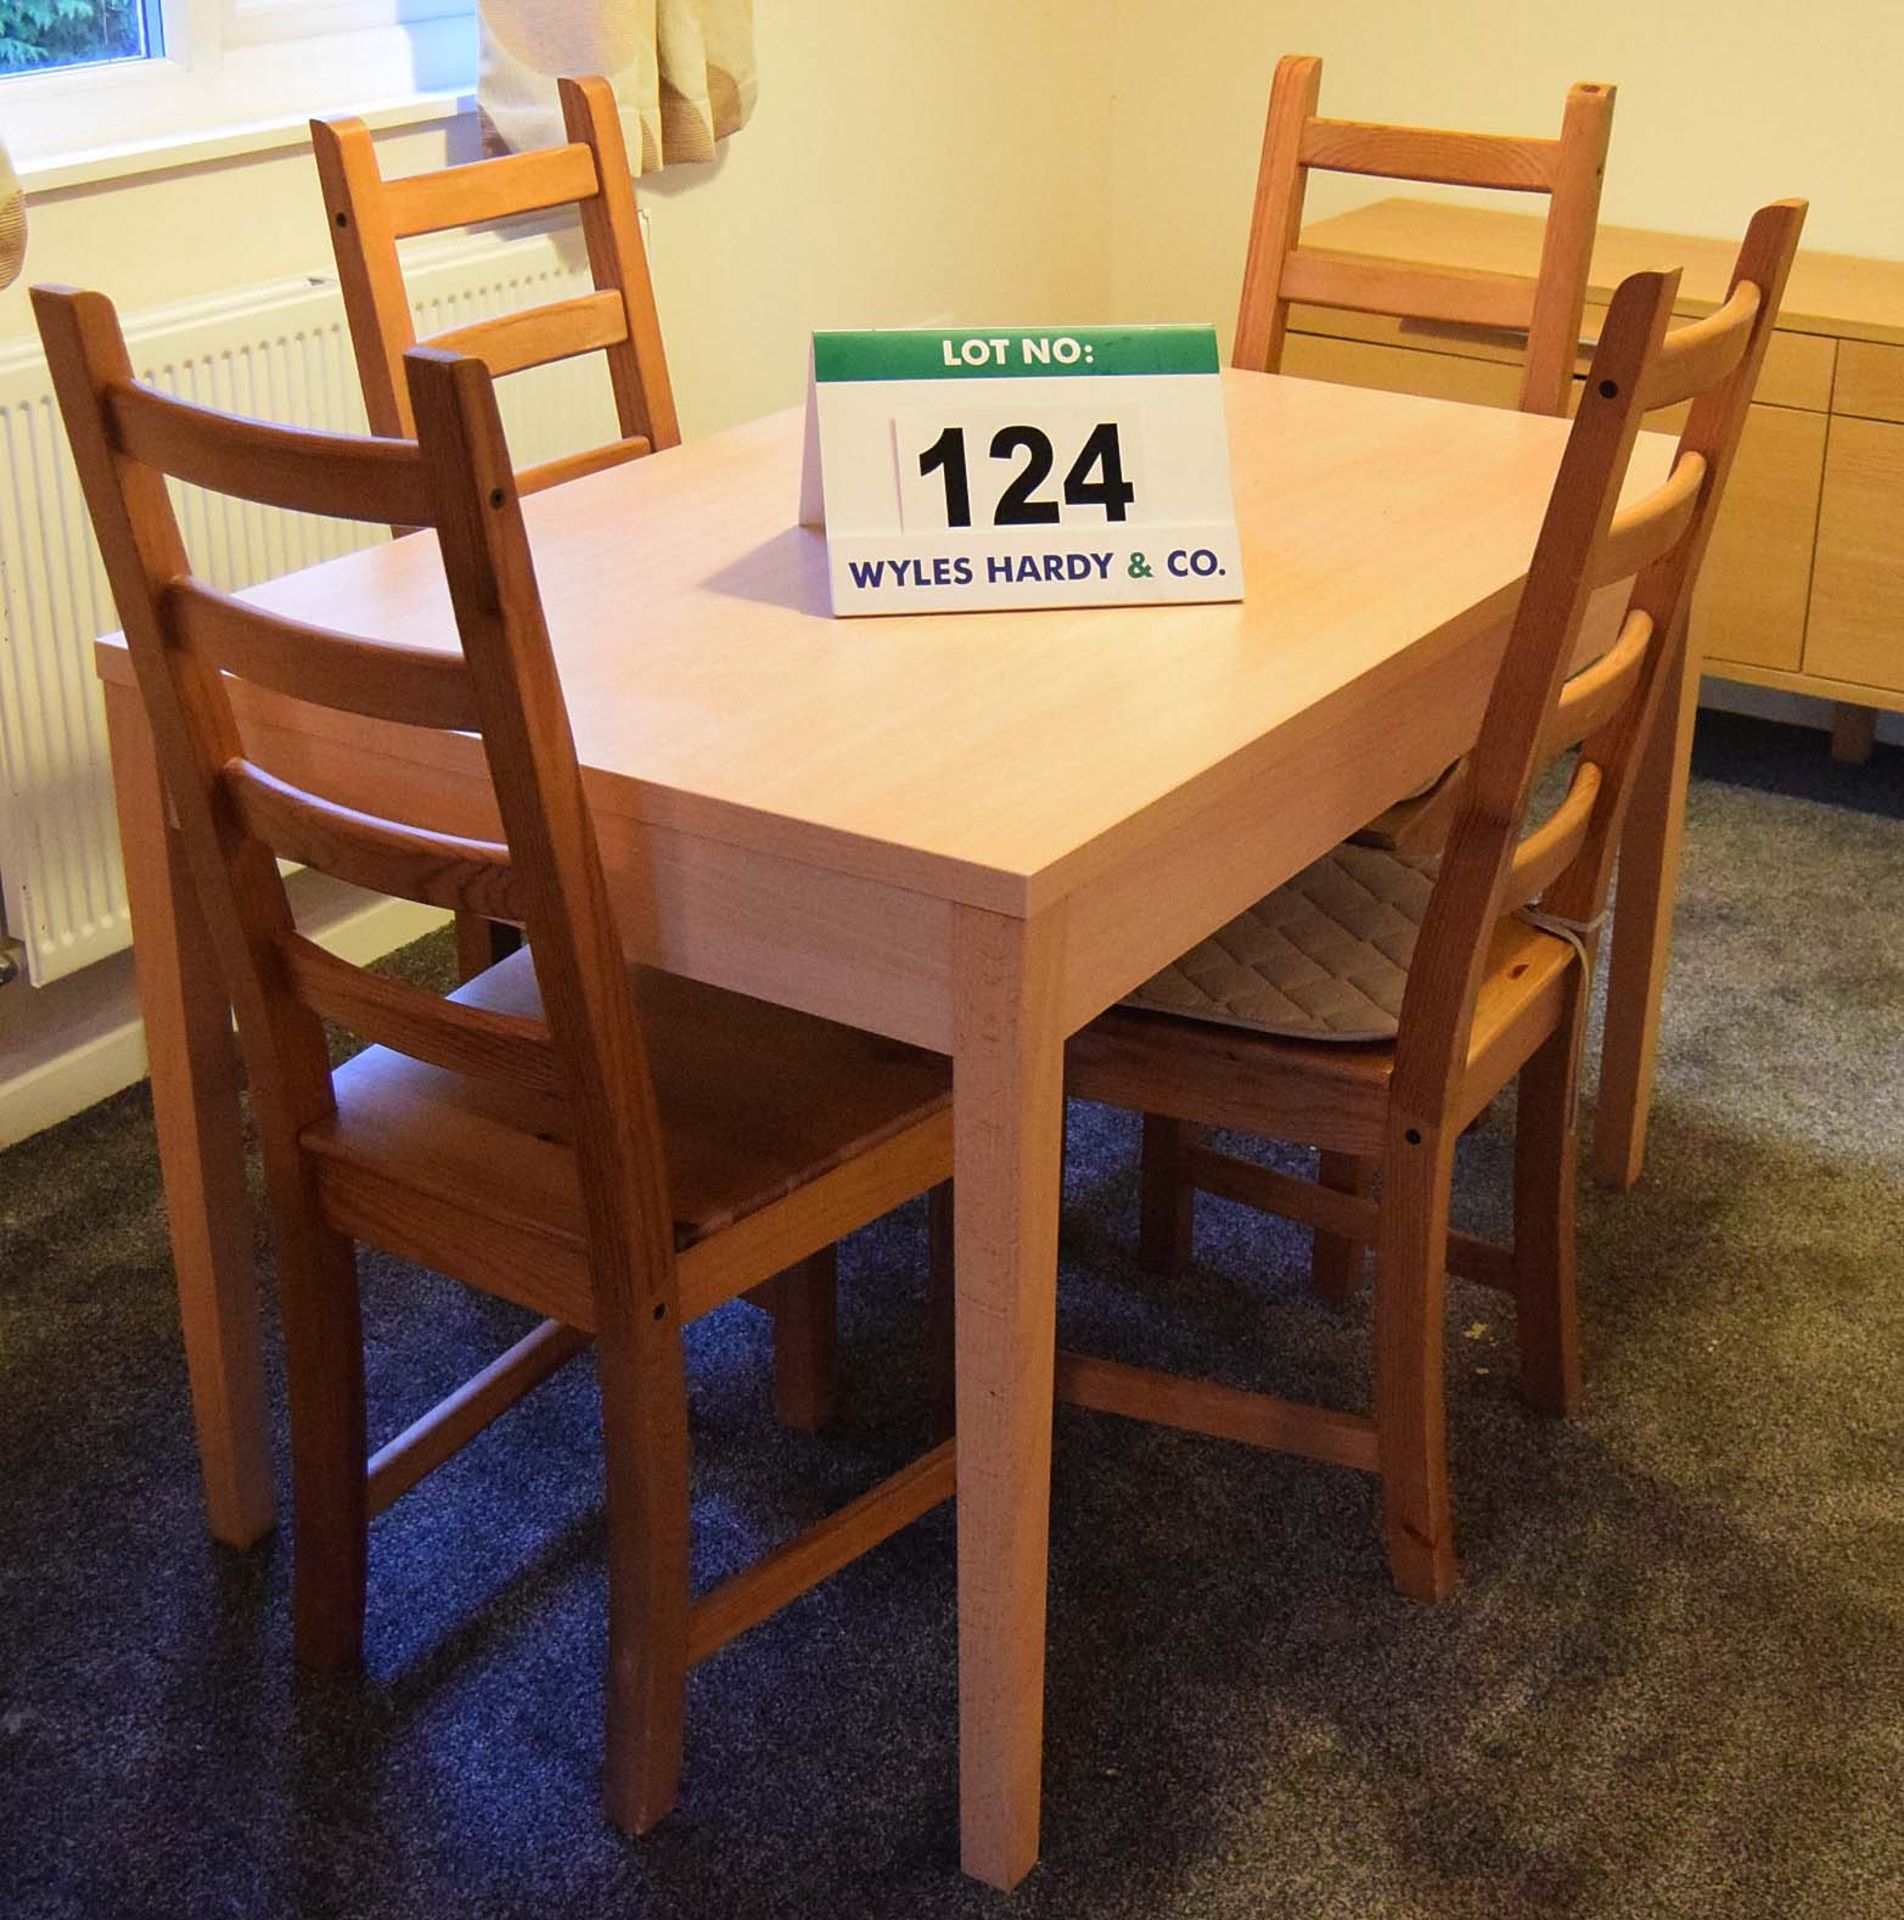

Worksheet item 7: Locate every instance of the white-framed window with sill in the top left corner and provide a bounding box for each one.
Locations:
[0,0,476,170]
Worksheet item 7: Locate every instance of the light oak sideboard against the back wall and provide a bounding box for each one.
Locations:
[1282,198,1904,758]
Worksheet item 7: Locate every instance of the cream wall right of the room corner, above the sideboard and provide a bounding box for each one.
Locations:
[1109,0,1904,338]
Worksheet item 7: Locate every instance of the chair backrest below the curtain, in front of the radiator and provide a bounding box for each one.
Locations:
[311,79,681,490]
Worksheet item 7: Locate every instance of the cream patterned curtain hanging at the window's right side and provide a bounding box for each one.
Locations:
[476,0,754,173]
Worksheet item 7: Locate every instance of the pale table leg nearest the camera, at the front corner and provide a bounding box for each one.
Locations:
[952,908,1063,1887]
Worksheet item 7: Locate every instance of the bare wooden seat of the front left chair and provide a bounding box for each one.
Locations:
[305,948,952,1327]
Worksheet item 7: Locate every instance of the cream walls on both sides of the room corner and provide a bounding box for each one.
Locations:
[11,0,1904,416]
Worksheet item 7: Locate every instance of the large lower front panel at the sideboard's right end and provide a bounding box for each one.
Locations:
[1804,416,1904,693]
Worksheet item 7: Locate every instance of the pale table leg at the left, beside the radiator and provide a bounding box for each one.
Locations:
[106,685,274,1548]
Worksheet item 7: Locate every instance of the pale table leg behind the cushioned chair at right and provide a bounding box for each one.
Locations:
[1593,618,1699,1188]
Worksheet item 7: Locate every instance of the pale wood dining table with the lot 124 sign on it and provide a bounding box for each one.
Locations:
[98,372,1673,1887]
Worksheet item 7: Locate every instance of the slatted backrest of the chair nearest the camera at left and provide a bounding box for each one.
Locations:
[33,286,674,1327]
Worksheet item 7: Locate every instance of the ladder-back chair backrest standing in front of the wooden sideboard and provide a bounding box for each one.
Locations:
[1232,54,1614,413]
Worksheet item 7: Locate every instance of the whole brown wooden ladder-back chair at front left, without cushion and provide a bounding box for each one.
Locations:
[35,288,967,1830]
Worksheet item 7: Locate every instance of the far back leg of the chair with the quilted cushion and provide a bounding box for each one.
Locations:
[1514,985,1585,1415]
